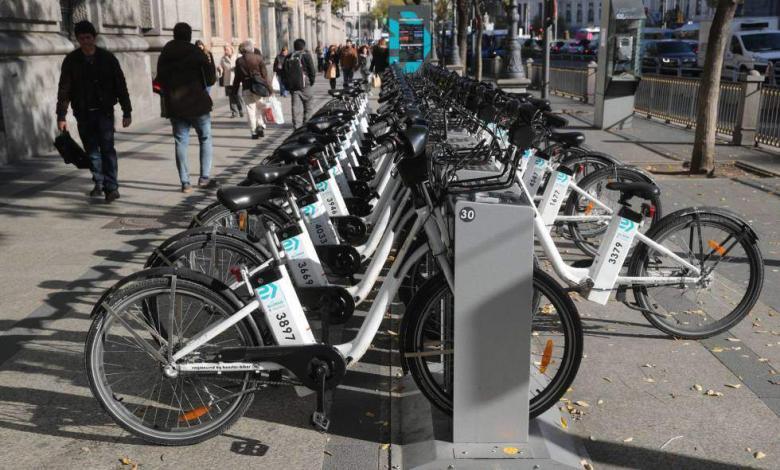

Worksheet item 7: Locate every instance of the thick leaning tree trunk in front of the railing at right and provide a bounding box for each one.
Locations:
[690,0,740,175]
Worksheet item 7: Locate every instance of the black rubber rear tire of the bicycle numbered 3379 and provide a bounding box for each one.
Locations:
[628,209,764,339]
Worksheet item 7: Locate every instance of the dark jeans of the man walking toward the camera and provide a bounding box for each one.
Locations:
[77,111,119,191]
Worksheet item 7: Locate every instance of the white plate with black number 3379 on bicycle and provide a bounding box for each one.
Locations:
[588,214,641,305]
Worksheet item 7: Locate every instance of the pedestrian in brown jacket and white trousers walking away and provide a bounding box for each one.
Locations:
[233,40,271,139]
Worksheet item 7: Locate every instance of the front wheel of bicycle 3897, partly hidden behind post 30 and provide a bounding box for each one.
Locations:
[401,269,583,418]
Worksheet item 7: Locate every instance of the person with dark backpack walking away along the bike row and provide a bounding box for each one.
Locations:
[282,38,317,129]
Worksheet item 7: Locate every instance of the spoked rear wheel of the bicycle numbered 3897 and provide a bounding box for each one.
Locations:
[85,271,259,445]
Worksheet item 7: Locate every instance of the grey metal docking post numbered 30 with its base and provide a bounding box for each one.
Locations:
[392,170,582,469]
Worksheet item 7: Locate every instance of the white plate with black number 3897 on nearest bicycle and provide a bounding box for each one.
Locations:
[257,266,315,346]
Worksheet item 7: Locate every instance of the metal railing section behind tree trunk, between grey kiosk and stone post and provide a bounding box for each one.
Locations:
[634,75,744,135]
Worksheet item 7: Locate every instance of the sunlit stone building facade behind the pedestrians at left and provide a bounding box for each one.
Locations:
[0,0,344,165]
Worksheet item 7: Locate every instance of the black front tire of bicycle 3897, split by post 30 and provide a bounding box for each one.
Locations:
[401,269,584,418]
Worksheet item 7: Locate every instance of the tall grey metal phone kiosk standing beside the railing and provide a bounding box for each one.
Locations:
[593,0,645,129]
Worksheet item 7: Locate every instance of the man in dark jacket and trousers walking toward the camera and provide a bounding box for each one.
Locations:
[57,21,133,203]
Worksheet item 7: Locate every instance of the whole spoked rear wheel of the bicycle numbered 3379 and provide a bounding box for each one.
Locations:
[628,211,764,339]
